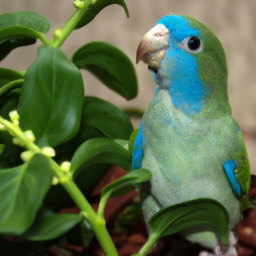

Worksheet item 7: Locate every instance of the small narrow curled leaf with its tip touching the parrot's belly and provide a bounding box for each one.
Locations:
[101,169,152,198]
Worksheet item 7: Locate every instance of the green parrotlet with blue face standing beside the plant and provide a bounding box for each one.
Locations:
[132,15,251,255]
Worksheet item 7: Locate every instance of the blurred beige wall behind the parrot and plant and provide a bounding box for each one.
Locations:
[0,0,256,174]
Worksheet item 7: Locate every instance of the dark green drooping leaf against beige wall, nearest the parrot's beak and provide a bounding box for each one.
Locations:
[72,42,138,100]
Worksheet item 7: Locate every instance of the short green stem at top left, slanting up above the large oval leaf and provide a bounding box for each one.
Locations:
[51,4,89,47]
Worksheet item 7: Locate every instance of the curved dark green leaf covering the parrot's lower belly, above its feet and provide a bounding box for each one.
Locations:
[148,199,229,244]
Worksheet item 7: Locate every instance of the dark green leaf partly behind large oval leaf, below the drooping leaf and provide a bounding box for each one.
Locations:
[82,97,133,140]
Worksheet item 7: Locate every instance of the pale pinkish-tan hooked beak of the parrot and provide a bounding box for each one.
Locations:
[136,24,169,69]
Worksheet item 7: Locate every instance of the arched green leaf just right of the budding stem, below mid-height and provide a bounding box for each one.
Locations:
[71,138,131,172]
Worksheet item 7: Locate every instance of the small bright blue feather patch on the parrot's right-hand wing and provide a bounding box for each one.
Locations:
[223,160,242,198]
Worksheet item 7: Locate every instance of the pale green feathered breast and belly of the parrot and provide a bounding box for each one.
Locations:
[141,89,240,227]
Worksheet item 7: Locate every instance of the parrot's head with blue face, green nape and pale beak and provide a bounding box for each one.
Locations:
[136,15,229,115]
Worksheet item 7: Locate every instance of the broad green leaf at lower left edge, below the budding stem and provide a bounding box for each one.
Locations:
[0,154,52,235]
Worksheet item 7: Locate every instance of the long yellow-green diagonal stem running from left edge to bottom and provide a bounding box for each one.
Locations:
[0,115,118,256]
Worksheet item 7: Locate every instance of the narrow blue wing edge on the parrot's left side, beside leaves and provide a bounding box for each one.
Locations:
[132,123,144,170]
